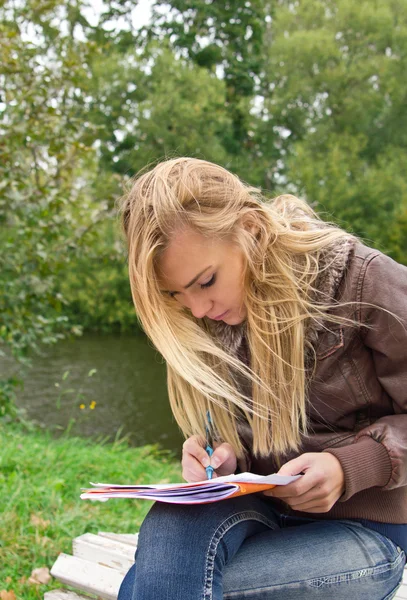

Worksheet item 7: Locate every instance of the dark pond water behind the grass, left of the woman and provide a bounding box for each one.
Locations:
[3,334,183,456]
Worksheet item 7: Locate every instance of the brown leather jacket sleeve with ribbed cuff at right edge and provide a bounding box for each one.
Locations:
[325,253,407,502]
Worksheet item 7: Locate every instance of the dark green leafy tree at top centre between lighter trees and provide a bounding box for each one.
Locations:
[148,0,270,158]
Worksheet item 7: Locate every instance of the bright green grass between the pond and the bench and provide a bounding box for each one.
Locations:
[0,423,181,600]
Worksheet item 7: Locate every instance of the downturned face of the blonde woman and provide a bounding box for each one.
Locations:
[158,229,247,325]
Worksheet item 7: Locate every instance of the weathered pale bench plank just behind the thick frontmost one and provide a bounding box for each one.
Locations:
[72,533,134,575]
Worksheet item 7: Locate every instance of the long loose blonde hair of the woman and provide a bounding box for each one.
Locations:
[121,158,356,456]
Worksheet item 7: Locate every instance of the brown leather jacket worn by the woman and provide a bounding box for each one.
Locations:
[242,243,407,523]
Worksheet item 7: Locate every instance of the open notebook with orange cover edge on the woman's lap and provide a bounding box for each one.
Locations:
[81,473,301,504]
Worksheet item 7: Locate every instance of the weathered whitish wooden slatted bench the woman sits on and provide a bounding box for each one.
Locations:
[44,531,407,600]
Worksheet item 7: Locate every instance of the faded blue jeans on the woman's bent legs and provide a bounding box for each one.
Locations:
[118,495,405,600]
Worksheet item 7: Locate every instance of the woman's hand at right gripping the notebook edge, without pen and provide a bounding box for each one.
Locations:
[264,452,345,513]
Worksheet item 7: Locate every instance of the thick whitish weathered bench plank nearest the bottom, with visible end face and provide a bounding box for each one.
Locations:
[51,554,123,600]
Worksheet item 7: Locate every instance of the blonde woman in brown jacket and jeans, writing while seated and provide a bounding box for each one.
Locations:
[119,158,407,600]
